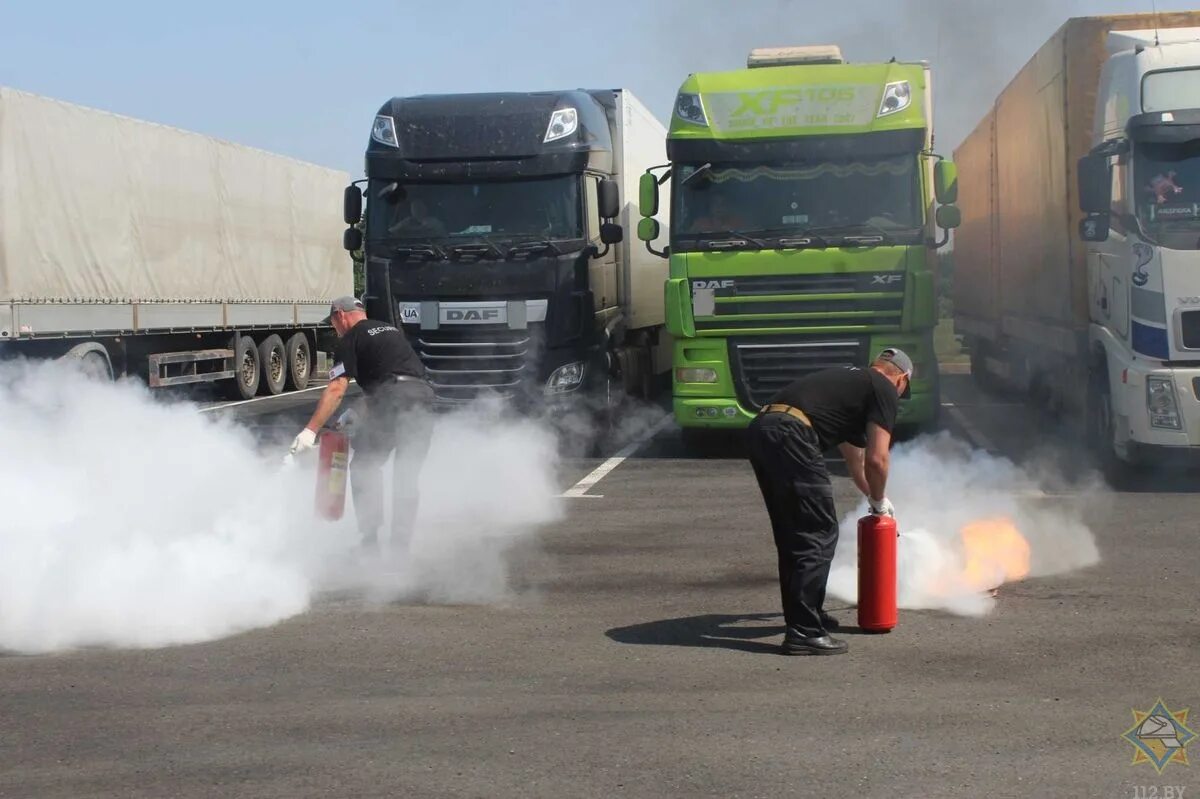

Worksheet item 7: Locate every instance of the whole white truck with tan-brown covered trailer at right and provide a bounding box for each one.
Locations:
[954,12,1200,475]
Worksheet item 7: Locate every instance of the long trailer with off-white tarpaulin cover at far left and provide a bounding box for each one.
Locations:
[0,88,354,398]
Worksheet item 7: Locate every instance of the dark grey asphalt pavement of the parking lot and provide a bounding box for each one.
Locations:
[0,376,1200,799]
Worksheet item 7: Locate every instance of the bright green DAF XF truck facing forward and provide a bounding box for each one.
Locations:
[638,46,960,440]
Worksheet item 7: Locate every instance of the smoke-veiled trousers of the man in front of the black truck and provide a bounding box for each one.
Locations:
[350,380,433,547]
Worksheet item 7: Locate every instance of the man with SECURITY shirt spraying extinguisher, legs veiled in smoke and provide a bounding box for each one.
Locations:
[292,296,433,548]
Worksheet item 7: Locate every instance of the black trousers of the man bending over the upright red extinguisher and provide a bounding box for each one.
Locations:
[749,414,838,636]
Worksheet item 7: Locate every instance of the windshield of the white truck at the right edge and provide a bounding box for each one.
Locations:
[1134,140,1200,250]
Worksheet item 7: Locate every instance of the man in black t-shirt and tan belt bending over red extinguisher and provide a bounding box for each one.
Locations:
[749,348,912,655]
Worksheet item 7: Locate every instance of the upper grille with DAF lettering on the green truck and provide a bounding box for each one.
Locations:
[696,272,906,330]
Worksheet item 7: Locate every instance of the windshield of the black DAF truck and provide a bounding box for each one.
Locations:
[367,175,583,244]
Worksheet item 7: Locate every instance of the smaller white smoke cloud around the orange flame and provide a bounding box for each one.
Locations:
[828,433,1100,615]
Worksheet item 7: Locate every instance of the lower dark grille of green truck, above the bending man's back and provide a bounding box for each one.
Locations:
[730,336,868,410]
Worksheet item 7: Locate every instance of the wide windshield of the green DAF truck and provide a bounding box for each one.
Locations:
[672,155,922,244]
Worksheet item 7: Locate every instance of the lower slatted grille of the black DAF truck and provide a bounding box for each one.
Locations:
[413,326,540,403]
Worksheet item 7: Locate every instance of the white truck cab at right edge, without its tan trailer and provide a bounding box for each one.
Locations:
[1079,28,1200,463]
